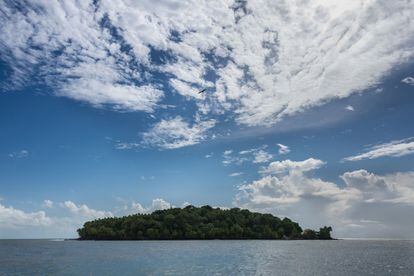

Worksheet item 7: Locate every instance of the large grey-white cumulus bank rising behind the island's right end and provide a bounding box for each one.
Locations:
[235,158,414,238]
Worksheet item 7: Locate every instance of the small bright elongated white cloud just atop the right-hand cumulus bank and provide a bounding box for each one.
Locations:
[260,158,325,174]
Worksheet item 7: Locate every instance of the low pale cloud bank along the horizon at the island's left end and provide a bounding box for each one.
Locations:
[0,198,174,238]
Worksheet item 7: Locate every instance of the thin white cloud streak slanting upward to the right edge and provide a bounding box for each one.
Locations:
[344,137,414,161]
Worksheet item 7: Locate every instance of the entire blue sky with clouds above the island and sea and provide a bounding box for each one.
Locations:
[0,0,414,239]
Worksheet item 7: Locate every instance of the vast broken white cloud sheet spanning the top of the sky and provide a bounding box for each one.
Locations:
[0,0,414,130]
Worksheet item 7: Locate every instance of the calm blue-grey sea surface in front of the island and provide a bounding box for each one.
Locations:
[0,240,414,275]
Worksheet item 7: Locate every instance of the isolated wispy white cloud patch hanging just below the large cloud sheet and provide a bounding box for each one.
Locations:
[142,116,216,149]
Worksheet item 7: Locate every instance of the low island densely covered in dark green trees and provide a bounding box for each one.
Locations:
[78,205,332,240]
